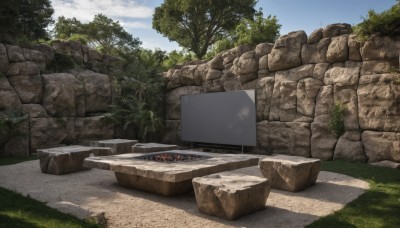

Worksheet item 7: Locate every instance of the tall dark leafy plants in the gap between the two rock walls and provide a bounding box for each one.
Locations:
[105,52,164,141]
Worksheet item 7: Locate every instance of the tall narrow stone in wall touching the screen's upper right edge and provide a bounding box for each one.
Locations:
[256,77,275,121]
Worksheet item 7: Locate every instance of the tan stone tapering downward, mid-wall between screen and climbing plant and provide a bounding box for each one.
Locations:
[296,78,322,117]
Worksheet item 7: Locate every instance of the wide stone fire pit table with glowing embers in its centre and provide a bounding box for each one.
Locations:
[83,150,259,196]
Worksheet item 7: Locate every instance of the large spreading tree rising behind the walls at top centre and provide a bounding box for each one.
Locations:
[153,0,257,59]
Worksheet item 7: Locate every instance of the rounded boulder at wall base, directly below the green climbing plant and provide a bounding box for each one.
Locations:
[333,131,366,162]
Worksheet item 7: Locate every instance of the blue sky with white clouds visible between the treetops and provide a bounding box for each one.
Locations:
[52,0,396,51]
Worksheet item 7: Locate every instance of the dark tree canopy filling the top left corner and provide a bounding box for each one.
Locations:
[0,0,54,42]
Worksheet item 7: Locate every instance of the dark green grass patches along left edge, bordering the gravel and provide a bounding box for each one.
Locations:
[0,156,99,228]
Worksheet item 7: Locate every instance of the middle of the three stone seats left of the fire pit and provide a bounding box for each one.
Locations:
[90,139,138,155]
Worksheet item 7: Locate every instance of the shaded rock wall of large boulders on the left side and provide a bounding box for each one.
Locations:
[0,41,122,155]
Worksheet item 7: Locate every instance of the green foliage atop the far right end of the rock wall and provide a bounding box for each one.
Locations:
[355,0,400,39]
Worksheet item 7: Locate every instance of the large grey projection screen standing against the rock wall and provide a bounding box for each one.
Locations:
[181,90,257,146]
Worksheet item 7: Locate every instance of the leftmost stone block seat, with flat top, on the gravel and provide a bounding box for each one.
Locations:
[37,145,110,175]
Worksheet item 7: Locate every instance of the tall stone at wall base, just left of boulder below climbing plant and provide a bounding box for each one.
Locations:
[311,115,337,160]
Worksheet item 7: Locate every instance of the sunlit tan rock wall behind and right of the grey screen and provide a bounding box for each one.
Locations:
[164,24,400,162]
